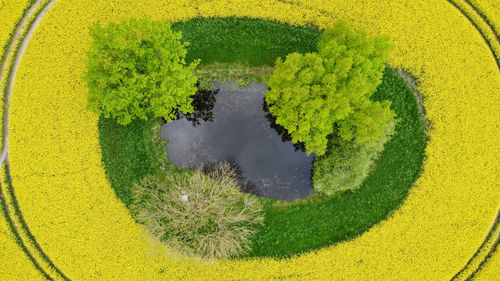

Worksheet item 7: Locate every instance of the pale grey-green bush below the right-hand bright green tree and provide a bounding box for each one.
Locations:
[313,119,396,195]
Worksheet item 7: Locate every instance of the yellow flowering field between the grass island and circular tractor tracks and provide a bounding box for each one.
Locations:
[4,0,500,280]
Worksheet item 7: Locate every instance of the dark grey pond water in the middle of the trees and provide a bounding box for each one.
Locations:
[161,83,313,200]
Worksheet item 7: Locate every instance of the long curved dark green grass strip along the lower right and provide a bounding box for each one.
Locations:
[251,69,425,257]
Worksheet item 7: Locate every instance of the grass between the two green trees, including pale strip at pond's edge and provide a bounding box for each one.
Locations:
[172,17,321,89]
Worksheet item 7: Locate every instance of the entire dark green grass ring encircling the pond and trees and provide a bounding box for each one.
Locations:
[95,18,425,257]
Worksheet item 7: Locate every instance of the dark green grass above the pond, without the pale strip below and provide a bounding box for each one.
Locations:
[172,18,321,66]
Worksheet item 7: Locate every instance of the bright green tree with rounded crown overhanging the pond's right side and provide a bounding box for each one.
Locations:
[266,20,394,155]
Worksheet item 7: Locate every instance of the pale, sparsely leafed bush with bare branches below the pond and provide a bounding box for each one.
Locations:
[132,163,263,258]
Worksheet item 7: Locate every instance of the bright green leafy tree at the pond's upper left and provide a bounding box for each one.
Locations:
[84,19,198,125]
